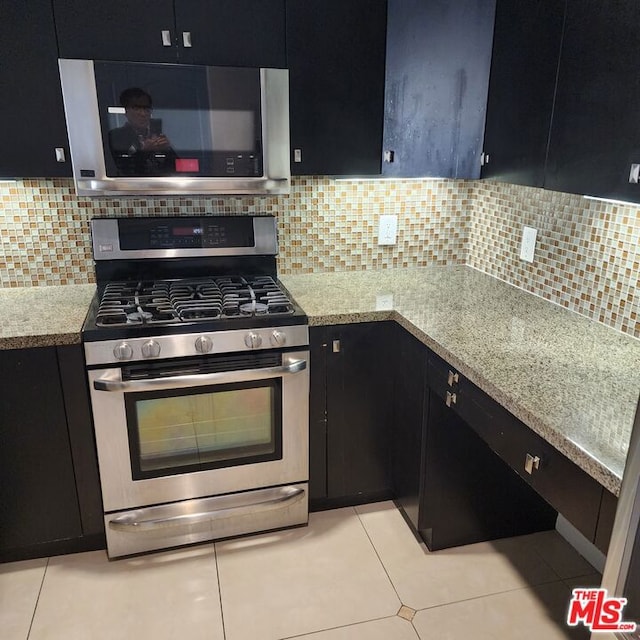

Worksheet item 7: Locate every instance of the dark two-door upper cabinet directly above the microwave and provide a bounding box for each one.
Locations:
[53,0,286,67]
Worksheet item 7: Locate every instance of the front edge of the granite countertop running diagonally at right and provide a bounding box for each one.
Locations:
[396,312,622,496]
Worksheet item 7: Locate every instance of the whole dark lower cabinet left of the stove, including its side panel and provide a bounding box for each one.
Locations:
[0,345,104,561]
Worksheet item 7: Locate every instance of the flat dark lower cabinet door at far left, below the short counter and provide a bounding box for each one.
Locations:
[0,347,82,552]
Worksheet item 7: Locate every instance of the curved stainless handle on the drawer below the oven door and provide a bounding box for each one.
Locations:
[109,486,305,533]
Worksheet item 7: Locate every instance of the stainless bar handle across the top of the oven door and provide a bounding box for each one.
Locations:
[93,360,307,392]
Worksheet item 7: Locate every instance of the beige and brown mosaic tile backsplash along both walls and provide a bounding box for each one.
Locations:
[0,177,640,337]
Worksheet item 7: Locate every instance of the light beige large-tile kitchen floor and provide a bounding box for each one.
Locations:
[0,502,600,640]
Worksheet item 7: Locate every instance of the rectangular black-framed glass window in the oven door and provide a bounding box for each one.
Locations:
[125,378,282,480]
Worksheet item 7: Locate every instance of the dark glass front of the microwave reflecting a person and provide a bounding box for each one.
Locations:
[94,62,262,178]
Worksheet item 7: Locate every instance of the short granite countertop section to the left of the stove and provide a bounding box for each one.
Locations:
[0,284,96,349]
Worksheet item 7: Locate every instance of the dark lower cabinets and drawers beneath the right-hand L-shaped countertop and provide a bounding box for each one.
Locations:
[310,322,616,551]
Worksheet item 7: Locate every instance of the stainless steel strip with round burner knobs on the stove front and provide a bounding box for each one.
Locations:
[84,325,309,365]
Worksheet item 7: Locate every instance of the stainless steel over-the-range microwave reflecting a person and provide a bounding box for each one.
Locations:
[58,59,290,196]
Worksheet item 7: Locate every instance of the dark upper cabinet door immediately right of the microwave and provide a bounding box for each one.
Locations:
[287,0,387,175]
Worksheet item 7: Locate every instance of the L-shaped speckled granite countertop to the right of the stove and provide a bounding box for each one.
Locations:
[280,267,640,495]
